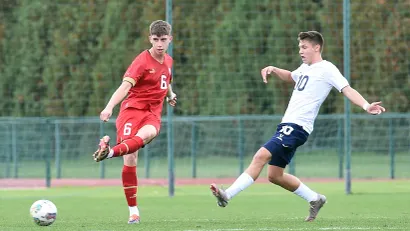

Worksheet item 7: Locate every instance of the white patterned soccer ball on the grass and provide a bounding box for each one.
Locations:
[30,200,57,226]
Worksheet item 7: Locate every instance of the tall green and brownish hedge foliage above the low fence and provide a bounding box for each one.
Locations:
[0,0,410,116]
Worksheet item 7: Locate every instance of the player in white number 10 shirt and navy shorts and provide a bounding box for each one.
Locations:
[210,31,385,221]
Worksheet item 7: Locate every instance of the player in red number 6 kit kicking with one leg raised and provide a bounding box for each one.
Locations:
[93,20,177,224]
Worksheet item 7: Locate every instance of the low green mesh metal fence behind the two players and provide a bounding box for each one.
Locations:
[0,114,410,185]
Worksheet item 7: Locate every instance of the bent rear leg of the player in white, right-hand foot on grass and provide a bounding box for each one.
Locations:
[268,165,326,221]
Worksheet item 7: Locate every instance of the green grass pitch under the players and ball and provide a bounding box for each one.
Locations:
[0,180,410,231]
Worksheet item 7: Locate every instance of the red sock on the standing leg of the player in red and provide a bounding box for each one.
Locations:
[122,165,138,206]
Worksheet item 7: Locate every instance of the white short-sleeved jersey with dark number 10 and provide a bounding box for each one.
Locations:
[282,60,349,134]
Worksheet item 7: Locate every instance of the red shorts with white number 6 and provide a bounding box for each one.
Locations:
[115,108,161,143]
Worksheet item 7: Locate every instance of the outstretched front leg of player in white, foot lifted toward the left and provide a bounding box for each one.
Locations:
[210,147,271,207]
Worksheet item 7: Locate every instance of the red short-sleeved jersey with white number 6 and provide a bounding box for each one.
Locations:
[121,50,173,115]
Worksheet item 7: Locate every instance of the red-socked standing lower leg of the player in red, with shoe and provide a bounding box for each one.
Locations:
[122,151,140,224]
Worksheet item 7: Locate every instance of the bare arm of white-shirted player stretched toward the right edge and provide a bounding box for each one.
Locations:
[342,86,386,115]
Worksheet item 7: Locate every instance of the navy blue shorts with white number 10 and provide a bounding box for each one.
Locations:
[263,123,309,168]
